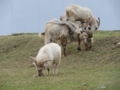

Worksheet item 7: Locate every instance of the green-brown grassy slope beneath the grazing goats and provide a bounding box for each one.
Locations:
[0,31,120,90]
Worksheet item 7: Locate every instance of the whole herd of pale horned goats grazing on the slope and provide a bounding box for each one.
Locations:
[30,4,100,76]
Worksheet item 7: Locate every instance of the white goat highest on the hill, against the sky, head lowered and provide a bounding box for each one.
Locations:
[60,4,100,31]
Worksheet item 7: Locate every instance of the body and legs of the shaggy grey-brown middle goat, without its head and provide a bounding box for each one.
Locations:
[45,20,92,56]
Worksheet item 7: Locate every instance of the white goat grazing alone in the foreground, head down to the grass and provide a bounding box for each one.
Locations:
[30,43,61,76]
